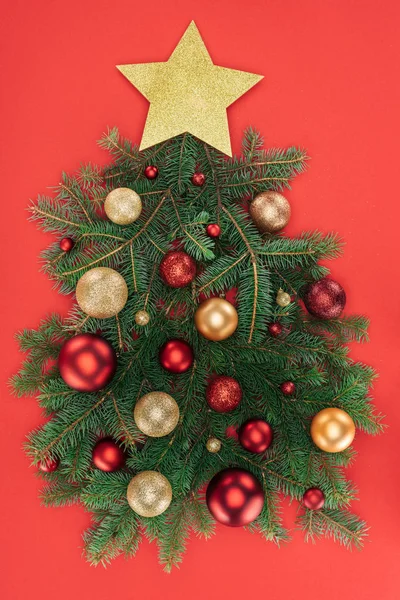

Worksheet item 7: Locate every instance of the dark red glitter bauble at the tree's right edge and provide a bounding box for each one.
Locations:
[303,277,346,319]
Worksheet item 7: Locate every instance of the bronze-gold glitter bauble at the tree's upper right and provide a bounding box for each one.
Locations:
[250,192,290,233]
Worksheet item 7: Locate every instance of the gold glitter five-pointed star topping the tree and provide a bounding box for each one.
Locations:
[117,21,262,156]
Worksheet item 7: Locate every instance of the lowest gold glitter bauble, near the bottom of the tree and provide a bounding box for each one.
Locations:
[126,471,172,517]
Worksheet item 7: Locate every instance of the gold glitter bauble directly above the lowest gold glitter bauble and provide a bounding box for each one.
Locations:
[133,392,179,437]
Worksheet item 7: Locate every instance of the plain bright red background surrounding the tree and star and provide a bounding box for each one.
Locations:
[0,0,400,600]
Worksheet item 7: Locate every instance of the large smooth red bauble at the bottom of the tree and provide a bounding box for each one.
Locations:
[206,468,264,527]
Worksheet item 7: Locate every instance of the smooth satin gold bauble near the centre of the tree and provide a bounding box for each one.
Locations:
[194,298,239,342]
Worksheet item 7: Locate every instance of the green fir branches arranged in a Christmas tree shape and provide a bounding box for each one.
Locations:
[12,129,382,570]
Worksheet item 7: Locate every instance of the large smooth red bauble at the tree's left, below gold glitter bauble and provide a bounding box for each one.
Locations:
[58,333,117,392]
